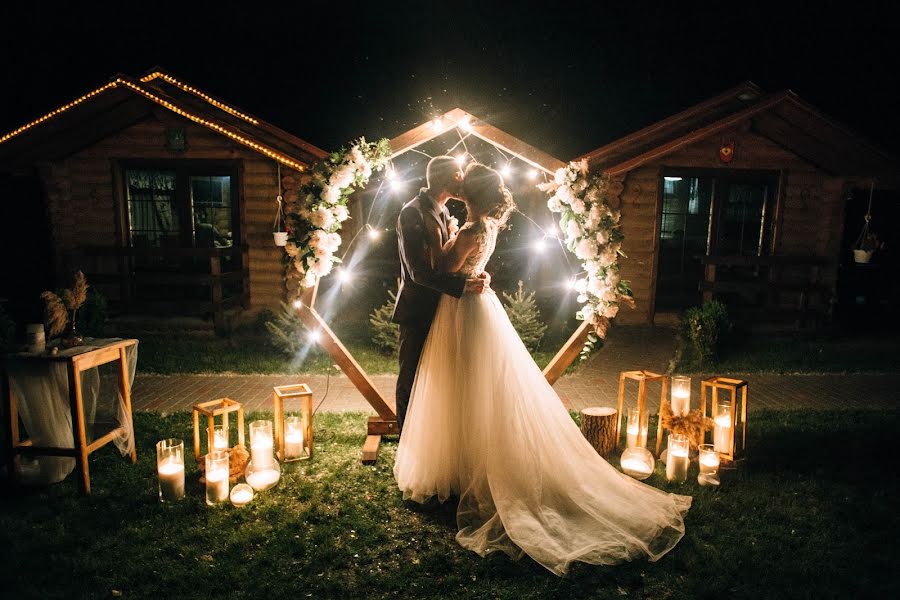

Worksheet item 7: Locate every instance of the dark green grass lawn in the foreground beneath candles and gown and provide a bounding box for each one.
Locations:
[0,411,900,600]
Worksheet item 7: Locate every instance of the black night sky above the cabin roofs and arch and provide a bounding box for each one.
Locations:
[0,1,900,160]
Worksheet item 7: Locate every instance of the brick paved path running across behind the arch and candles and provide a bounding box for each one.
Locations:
[132,326,900,414]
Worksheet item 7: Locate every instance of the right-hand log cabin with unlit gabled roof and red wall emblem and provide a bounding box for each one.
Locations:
[578,82,900,329]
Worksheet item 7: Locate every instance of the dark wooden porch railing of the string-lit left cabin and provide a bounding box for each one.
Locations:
[69,245,250,331]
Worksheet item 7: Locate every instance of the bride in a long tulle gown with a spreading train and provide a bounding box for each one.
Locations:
[394,164,691,575]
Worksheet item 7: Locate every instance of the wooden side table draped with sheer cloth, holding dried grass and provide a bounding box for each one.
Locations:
[0,339,137,494]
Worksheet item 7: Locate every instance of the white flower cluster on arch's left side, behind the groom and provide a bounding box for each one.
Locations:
[285,137,391,289]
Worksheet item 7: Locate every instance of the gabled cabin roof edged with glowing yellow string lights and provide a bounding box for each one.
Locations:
[0,69,327,170]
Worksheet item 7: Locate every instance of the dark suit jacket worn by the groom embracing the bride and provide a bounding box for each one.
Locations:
[391,188,466,328]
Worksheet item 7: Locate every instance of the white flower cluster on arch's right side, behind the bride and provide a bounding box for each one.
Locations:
[538,160,634,356]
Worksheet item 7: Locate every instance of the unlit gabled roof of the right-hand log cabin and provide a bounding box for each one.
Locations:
[576,81,900,177]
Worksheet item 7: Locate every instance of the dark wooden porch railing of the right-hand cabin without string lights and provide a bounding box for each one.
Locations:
[698,255,837,327]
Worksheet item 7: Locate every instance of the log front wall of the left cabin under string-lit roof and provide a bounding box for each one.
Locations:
[41,109,291,311]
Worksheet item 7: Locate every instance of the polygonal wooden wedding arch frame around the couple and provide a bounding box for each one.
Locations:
[298,108,590,464]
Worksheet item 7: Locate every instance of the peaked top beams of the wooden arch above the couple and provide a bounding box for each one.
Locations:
[390,108,566,175]
